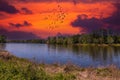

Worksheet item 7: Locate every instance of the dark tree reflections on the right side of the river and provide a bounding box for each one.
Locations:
[50,45,120,66]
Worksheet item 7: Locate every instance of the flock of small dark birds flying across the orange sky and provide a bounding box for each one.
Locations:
[42,0,76,35]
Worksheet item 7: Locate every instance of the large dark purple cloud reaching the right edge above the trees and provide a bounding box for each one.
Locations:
[71,3,120,32]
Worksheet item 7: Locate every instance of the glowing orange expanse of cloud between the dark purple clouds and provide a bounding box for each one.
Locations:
[0,2,116,38]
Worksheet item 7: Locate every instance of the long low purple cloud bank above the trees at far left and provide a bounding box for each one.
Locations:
[0,28,39,40]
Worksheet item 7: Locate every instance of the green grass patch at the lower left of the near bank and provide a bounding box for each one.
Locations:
[0,57,75,80]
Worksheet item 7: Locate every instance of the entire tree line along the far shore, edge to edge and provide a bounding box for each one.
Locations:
[0,29,120,44]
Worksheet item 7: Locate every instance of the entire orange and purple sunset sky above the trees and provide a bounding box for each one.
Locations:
[0,0,120,39]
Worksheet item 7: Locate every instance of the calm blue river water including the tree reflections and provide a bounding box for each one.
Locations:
[0,43,120,67]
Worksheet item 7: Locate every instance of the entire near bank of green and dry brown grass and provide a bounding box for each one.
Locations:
[0,51,120,80]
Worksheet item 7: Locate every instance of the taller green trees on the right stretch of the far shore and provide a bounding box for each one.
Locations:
[47,29,120,44]
